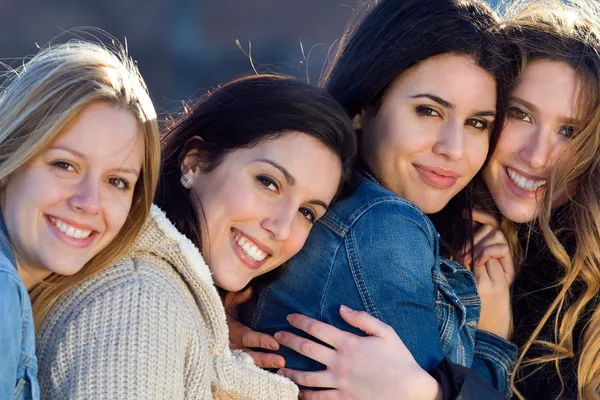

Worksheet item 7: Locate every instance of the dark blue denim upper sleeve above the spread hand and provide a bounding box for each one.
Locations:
[325,202,444,370]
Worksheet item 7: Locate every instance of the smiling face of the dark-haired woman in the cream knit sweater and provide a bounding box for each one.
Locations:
[188,132,342,291]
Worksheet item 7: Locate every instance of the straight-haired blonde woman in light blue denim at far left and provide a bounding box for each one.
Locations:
[0,42,160,399]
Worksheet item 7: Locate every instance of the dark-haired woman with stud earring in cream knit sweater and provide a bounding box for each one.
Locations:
[38,76,356,400]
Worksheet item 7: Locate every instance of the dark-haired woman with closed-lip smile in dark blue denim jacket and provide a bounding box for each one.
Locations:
[238,0,516,393]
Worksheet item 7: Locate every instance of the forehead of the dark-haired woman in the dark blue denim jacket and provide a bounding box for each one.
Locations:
[391,54,496,111]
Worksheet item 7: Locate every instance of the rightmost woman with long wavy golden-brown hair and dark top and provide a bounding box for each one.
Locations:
[482,1,600,399]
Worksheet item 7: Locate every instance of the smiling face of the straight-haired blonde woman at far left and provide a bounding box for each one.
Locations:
[2,103,144,279]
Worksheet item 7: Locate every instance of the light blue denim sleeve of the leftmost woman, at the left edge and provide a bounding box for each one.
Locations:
[0,271,23,399]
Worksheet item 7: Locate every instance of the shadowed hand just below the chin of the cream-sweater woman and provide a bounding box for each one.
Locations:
[223,287,285,368]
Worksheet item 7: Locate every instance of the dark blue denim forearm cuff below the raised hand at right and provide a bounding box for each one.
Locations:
[471,330,518,399]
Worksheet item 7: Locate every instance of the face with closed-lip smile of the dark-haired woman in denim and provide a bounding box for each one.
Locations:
[361,54,496,213]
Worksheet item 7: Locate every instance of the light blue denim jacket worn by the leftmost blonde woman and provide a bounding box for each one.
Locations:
[0,214,40,400]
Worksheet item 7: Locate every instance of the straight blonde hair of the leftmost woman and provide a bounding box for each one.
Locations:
[0,40,160,327]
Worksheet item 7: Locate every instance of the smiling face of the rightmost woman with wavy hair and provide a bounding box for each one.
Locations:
[483,60,581,223]
